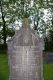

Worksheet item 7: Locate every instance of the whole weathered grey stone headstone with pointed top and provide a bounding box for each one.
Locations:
[8,18,44,80]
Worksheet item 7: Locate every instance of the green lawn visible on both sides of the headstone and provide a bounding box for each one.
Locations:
[0,51,53,80]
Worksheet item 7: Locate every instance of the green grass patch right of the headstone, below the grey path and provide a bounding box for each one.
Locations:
[44,64,53,80]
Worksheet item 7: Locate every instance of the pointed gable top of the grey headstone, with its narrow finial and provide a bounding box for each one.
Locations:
[7,18,44,49]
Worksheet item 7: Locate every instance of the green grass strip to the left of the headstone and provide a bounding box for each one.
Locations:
[0,52,9,80]
